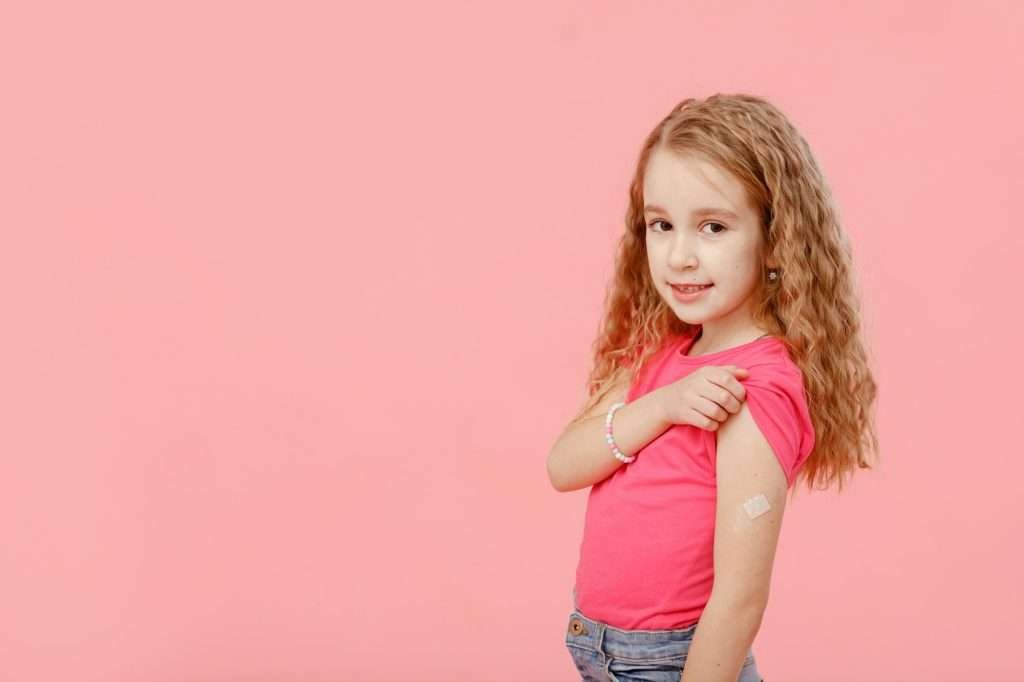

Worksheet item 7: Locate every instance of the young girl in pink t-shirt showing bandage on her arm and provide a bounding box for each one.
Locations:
[548,94,878,682]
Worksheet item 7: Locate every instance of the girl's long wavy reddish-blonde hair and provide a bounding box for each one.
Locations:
[573,93,879,492]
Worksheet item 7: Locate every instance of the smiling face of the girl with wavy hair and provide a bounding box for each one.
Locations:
[643,146,764,337]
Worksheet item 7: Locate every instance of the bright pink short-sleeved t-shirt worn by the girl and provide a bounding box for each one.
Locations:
[574,328,814,630]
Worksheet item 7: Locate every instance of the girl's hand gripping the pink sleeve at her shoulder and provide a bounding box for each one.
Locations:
[657,365,750,431]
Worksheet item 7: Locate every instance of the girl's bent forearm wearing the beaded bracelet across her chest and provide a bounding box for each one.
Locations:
[548,390,672,493]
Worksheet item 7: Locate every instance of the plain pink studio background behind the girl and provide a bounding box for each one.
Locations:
[0,1,1024,682]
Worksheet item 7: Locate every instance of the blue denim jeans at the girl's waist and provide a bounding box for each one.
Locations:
[565,592,764,682]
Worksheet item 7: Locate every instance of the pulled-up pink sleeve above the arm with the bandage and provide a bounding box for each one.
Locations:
[741,363,814,486]
